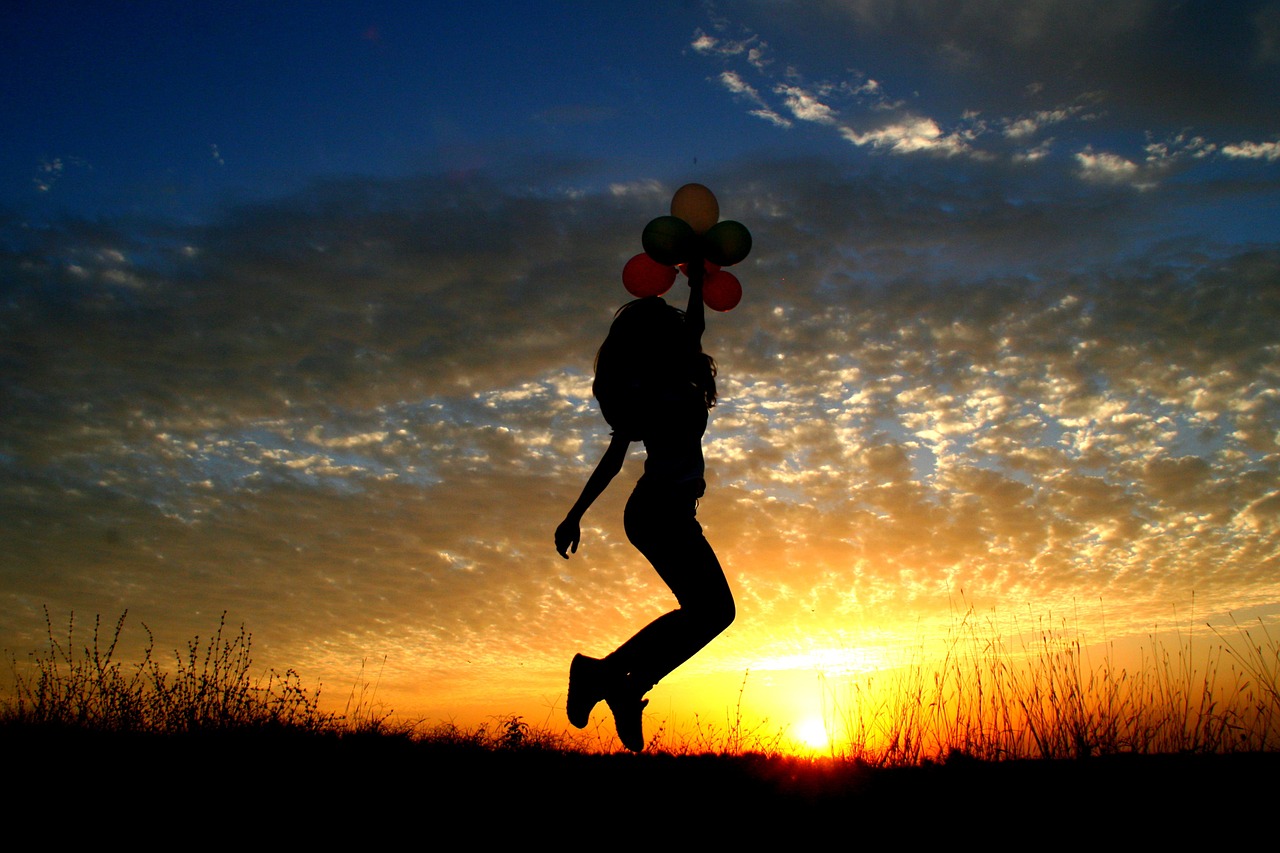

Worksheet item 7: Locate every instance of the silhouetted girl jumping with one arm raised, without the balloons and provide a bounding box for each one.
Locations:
[556,270,733,752]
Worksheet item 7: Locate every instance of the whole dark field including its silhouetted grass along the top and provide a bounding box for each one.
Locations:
[0,604,1280,840]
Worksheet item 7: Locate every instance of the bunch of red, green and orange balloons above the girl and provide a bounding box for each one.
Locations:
[622,183,751,311]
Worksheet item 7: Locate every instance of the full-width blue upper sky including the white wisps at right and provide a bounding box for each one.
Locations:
[12,3,1277,225]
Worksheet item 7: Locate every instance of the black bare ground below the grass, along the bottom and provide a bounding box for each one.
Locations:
[10,729,1280,835]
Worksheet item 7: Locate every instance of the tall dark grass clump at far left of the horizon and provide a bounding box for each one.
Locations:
[3,608,340,734]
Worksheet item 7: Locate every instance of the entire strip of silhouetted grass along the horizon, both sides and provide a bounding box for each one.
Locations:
[0,608,1280,767]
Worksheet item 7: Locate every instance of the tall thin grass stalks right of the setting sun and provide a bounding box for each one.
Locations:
[824,601,1280,766]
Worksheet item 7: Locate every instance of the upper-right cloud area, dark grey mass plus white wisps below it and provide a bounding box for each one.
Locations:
[695,0,1280,181]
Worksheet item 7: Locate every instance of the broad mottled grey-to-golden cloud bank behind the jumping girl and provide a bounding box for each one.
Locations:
[0,156,1280,712]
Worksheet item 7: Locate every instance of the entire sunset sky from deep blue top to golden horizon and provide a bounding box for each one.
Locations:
[0,0,1280,742]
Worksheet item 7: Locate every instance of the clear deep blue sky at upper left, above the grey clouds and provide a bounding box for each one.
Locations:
[4,3,746,215]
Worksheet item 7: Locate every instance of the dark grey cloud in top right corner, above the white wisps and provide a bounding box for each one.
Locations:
[793,0,1280,128]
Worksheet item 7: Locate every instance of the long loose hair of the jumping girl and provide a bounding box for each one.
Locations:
[591,296,716,433]
